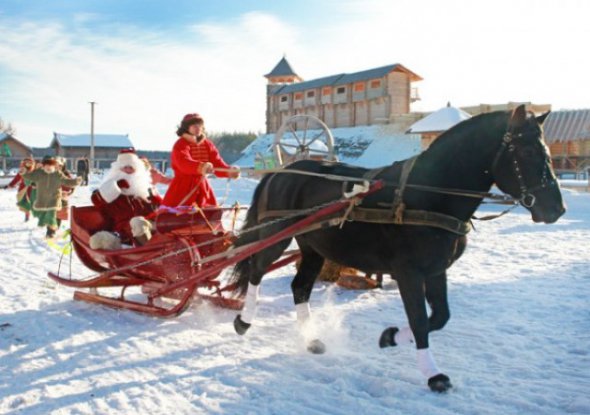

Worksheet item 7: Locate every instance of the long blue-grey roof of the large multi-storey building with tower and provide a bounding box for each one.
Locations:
[272,63,422,95]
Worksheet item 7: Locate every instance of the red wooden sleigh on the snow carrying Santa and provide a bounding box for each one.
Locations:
[48,206,298,317]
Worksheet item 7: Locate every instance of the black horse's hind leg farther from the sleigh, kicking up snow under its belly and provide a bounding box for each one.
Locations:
[291,244,326,354]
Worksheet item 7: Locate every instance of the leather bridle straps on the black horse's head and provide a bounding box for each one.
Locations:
[491,131,557,208]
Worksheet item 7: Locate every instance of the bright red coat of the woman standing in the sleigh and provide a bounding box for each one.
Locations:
[162,137,230,207]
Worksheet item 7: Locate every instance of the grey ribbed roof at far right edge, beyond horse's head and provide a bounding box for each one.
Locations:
[543,109,590,143]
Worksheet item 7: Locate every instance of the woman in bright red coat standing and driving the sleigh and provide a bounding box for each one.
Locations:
[162,114,240,207]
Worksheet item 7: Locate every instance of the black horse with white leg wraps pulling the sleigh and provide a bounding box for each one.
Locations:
[233,106,565,392]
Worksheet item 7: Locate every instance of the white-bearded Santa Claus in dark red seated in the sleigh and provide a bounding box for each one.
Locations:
[90,149,162,249]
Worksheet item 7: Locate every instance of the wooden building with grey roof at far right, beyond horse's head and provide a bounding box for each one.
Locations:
[543,109,590,175]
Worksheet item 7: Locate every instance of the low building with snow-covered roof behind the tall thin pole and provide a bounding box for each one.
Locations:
[49,132,133,169]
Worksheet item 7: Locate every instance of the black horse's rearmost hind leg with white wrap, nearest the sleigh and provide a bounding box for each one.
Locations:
[234,238,291,335]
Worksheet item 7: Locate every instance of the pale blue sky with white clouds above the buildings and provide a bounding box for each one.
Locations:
[0,0,590,150]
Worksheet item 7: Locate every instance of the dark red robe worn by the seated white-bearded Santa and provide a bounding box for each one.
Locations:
[90,189,162,244]
